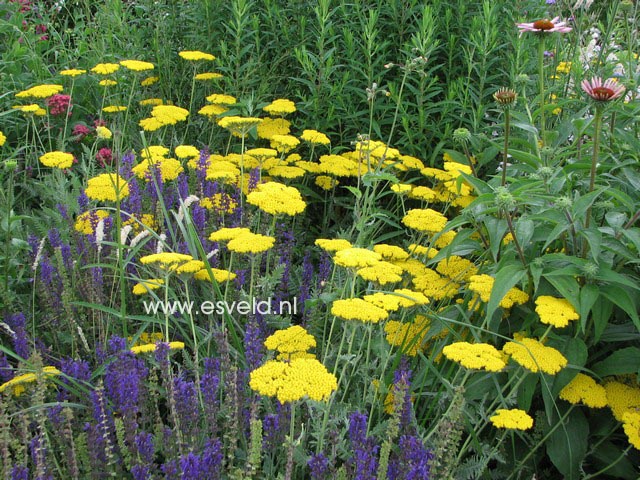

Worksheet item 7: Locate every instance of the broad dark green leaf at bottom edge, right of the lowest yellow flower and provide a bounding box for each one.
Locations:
[547,405,589,480]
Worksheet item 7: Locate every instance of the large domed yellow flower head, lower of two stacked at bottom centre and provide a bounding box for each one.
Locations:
[249,358,338,404]
